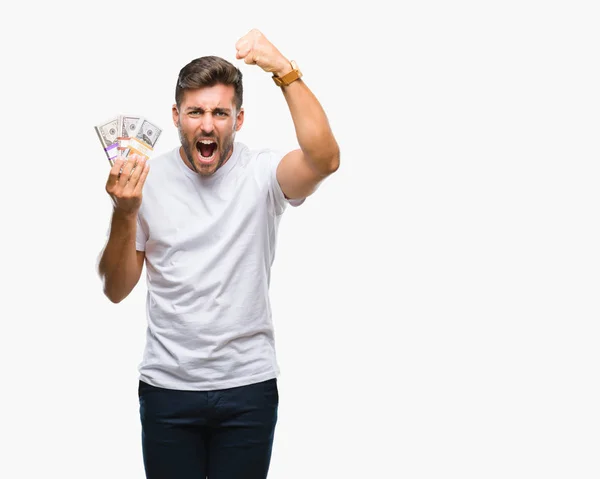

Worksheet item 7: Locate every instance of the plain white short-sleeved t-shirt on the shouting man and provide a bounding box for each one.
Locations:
[136,142,303,390]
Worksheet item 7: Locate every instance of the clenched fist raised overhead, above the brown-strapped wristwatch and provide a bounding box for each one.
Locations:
[235,29,292,76]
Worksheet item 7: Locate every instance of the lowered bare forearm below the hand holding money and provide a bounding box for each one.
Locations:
[98,210,141,303]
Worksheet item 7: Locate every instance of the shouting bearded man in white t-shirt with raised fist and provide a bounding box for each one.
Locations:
[98,30,340,479]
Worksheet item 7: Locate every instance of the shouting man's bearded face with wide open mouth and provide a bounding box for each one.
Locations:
[173,85,244,176]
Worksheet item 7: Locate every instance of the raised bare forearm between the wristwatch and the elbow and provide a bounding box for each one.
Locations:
[282,80,340,174]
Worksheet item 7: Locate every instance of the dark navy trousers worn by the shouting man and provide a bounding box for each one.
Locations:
[138,379,279,479]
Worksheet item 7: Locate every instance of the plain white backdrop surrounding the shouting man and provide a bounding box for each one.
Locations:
[0,1,600,479]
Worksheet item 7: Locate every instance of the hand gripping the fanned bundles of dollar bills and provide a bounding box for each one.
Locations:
[106,155,150,215]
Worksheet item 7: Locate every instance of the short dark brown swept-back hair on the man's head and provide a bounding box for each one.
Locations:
[175,55,244,111]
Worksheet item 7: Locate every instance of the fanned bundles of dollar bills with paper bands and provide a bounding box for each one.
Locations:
[94,115,162,166]
